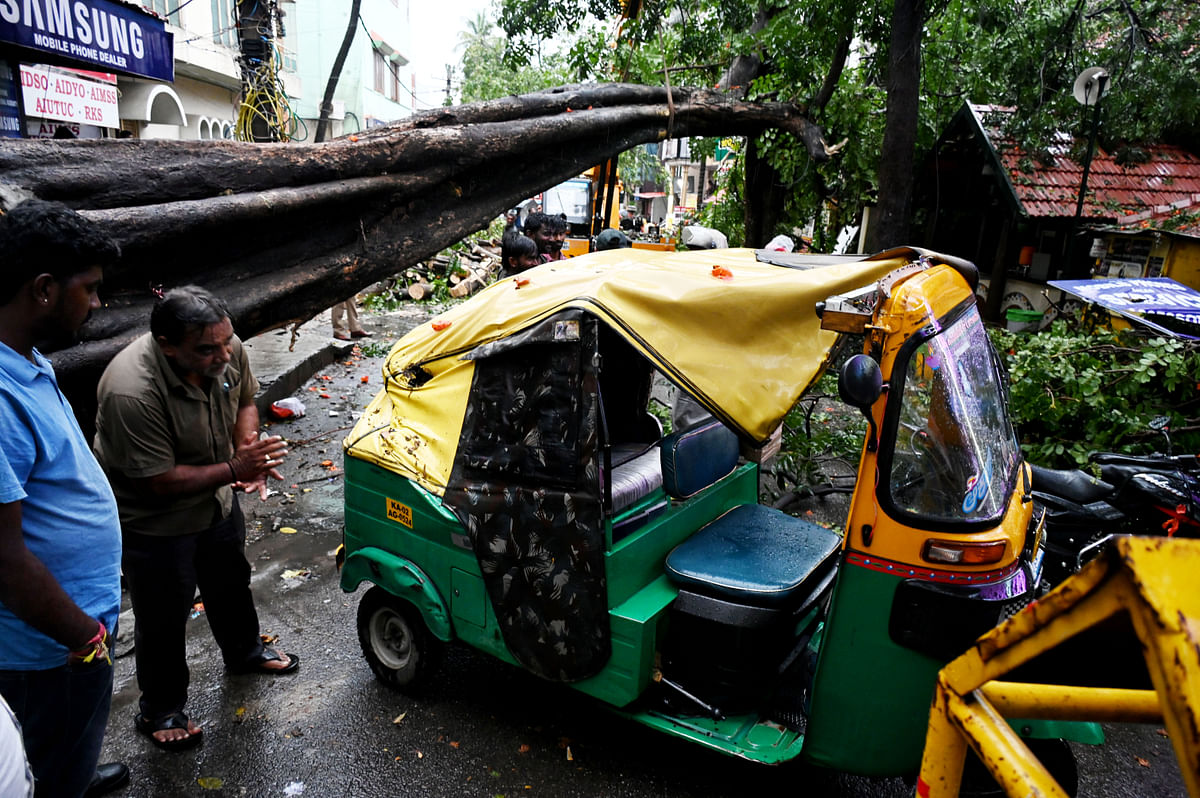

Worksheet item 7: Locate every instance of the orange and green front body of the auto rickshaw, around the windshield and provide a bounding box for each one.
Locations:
[803,260,1060,775]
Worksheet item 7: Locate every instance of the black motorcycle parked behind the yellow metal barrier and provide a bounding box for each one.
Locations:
[1032,416,1200,584]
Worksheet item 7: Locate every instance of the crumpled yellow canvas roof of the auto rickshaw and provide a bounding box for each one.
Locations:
[346,248,918,494]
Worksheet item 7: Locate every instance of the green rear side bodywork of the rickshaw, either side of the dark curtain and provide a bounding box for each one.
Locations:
[341,441,758,707]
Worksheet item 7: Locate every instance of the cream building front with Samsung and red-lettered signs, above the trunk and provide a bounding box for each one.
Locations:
[0,0,299,140]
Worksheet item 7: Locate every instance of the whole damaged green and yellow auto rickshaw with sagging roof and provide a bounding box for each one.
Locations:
[341,248,1099,775]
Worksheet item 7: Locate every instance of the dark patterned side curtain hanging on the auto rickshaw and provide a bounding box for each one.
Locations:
[443,311,611,682]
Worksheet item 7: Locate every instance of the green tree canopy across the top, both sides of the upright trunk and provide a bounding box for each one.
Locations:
[487,0,1200,248]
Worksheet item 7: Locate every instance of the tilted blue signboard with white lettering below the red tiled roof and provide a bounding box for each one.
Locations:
[1050,277,1200,338]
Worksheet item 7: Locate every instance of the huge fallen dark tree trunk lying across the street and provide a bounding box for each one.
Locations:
[0,84,827,405]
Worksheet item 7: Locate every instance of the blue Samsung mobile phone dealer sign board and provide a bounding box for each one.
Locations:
[0,0,175,82]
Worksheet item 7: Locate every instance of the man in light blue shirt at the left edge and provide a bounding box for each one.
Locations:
[0,200,128,798]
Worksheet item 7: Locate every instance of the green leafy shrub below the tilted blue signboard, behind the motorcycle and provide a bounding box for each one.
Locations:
[991,320,1200,468]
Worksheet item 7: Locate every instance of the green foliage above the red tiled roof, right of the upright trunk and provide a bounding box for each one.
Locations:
[942,0,1200,160]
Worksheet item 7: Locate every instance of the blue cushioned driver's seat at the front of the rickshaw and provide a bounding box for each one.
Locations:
[666,504,841,607]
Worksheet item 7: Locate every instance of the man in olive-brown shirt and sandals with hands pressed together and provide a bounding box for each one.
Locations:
[95,286,300,750]
